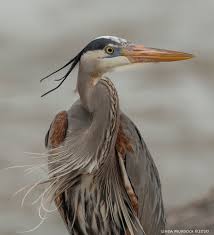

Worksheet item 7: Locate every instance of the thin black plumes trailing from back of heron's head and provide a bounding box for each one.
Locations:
[40,51,83,97]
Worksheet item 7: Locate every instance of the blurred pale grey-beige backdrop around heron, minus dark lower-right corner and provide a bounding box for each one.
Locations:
[0,0,214,235]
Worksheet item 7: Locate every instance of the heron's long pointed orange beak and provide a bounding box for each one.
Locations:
[122,44,194,63]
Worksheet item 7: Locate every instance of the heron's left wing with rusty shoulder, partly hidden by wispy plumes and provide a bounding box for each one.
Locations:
[45,100,91,231]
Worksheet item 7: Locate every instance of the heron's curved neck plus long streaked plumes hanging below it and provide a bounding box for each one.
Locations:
[78,69,137,234]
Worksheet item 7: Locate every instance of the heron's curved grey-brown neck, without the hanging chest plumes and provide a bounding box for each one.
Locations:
[77,68,119,162]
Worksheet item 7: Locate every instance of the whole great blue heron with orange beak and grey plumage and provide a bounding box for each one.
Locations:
[42,36,192,235]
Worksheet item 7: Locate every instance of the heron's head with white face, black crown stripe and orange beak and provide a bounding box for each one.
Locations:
[80,36,193,74]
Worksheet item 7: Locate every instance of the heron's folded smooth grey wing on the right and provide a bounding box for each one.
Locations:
[120,114,165,235]
